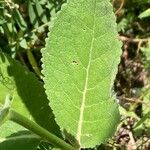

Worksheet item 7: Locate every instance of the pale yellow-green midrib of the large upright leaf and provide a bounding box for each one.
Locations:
[76,0,96,145]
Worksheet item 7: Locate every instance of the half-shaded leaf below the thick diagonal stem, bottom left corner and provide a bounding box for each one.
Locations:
[0,121,40,150]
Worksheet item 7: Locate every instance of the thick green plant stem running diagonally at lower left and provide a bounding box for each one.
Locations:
[9,110,77,150]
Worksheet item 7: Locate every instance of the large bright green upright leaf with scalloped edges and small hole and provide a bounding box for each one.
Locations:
[42,0,121,148]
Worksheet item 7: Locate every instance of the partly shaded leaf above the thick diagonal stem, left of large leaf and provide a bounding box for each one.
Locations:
[0,52,60,135]
